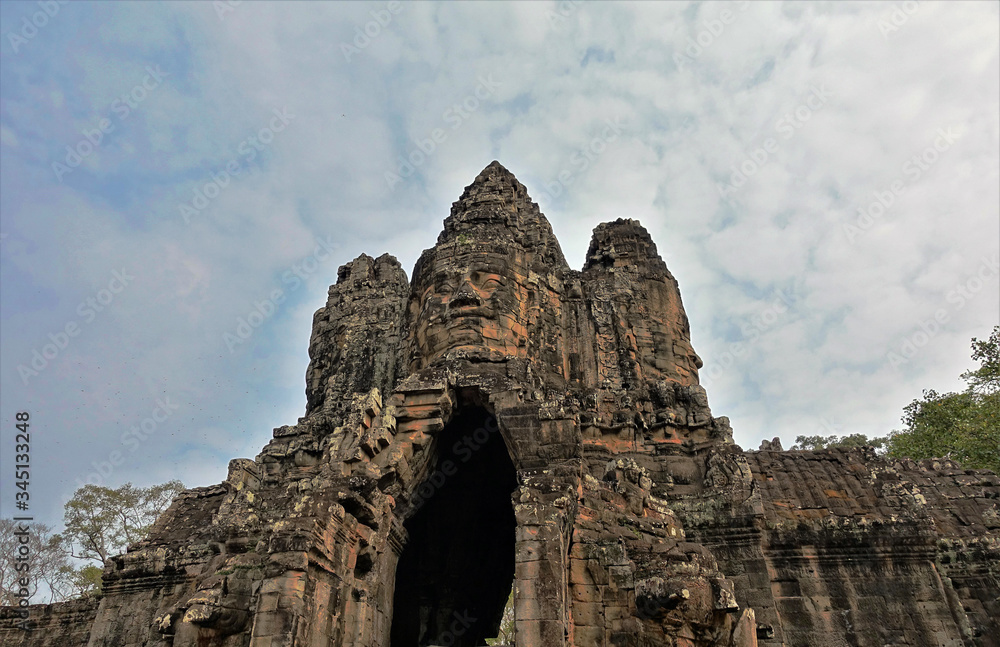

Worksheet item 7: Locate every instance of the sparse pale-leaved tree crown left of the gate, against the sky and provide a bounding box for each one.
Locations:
[63,481,184,565]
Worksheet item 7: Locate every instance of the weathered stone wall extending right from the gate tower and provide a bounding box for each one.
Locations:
[677,449,1000,647]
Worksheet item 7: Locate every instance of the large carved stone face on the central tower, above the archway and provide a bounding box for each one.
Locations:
[410,242,528,365]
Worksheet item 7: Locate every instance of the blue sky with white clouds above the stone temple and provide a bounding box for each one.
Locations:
[0,0,1000,525]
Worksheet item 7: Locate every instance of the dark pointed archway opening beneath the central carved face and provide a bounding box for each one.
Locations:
[390,407,517,647]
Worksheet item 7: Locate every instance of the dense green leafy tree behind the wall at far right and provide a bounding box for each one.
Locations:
[888,326,1000,473]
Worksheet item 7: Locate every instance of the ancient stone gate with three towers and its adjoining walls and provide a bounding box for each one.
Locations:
[0,162,1000,647]
